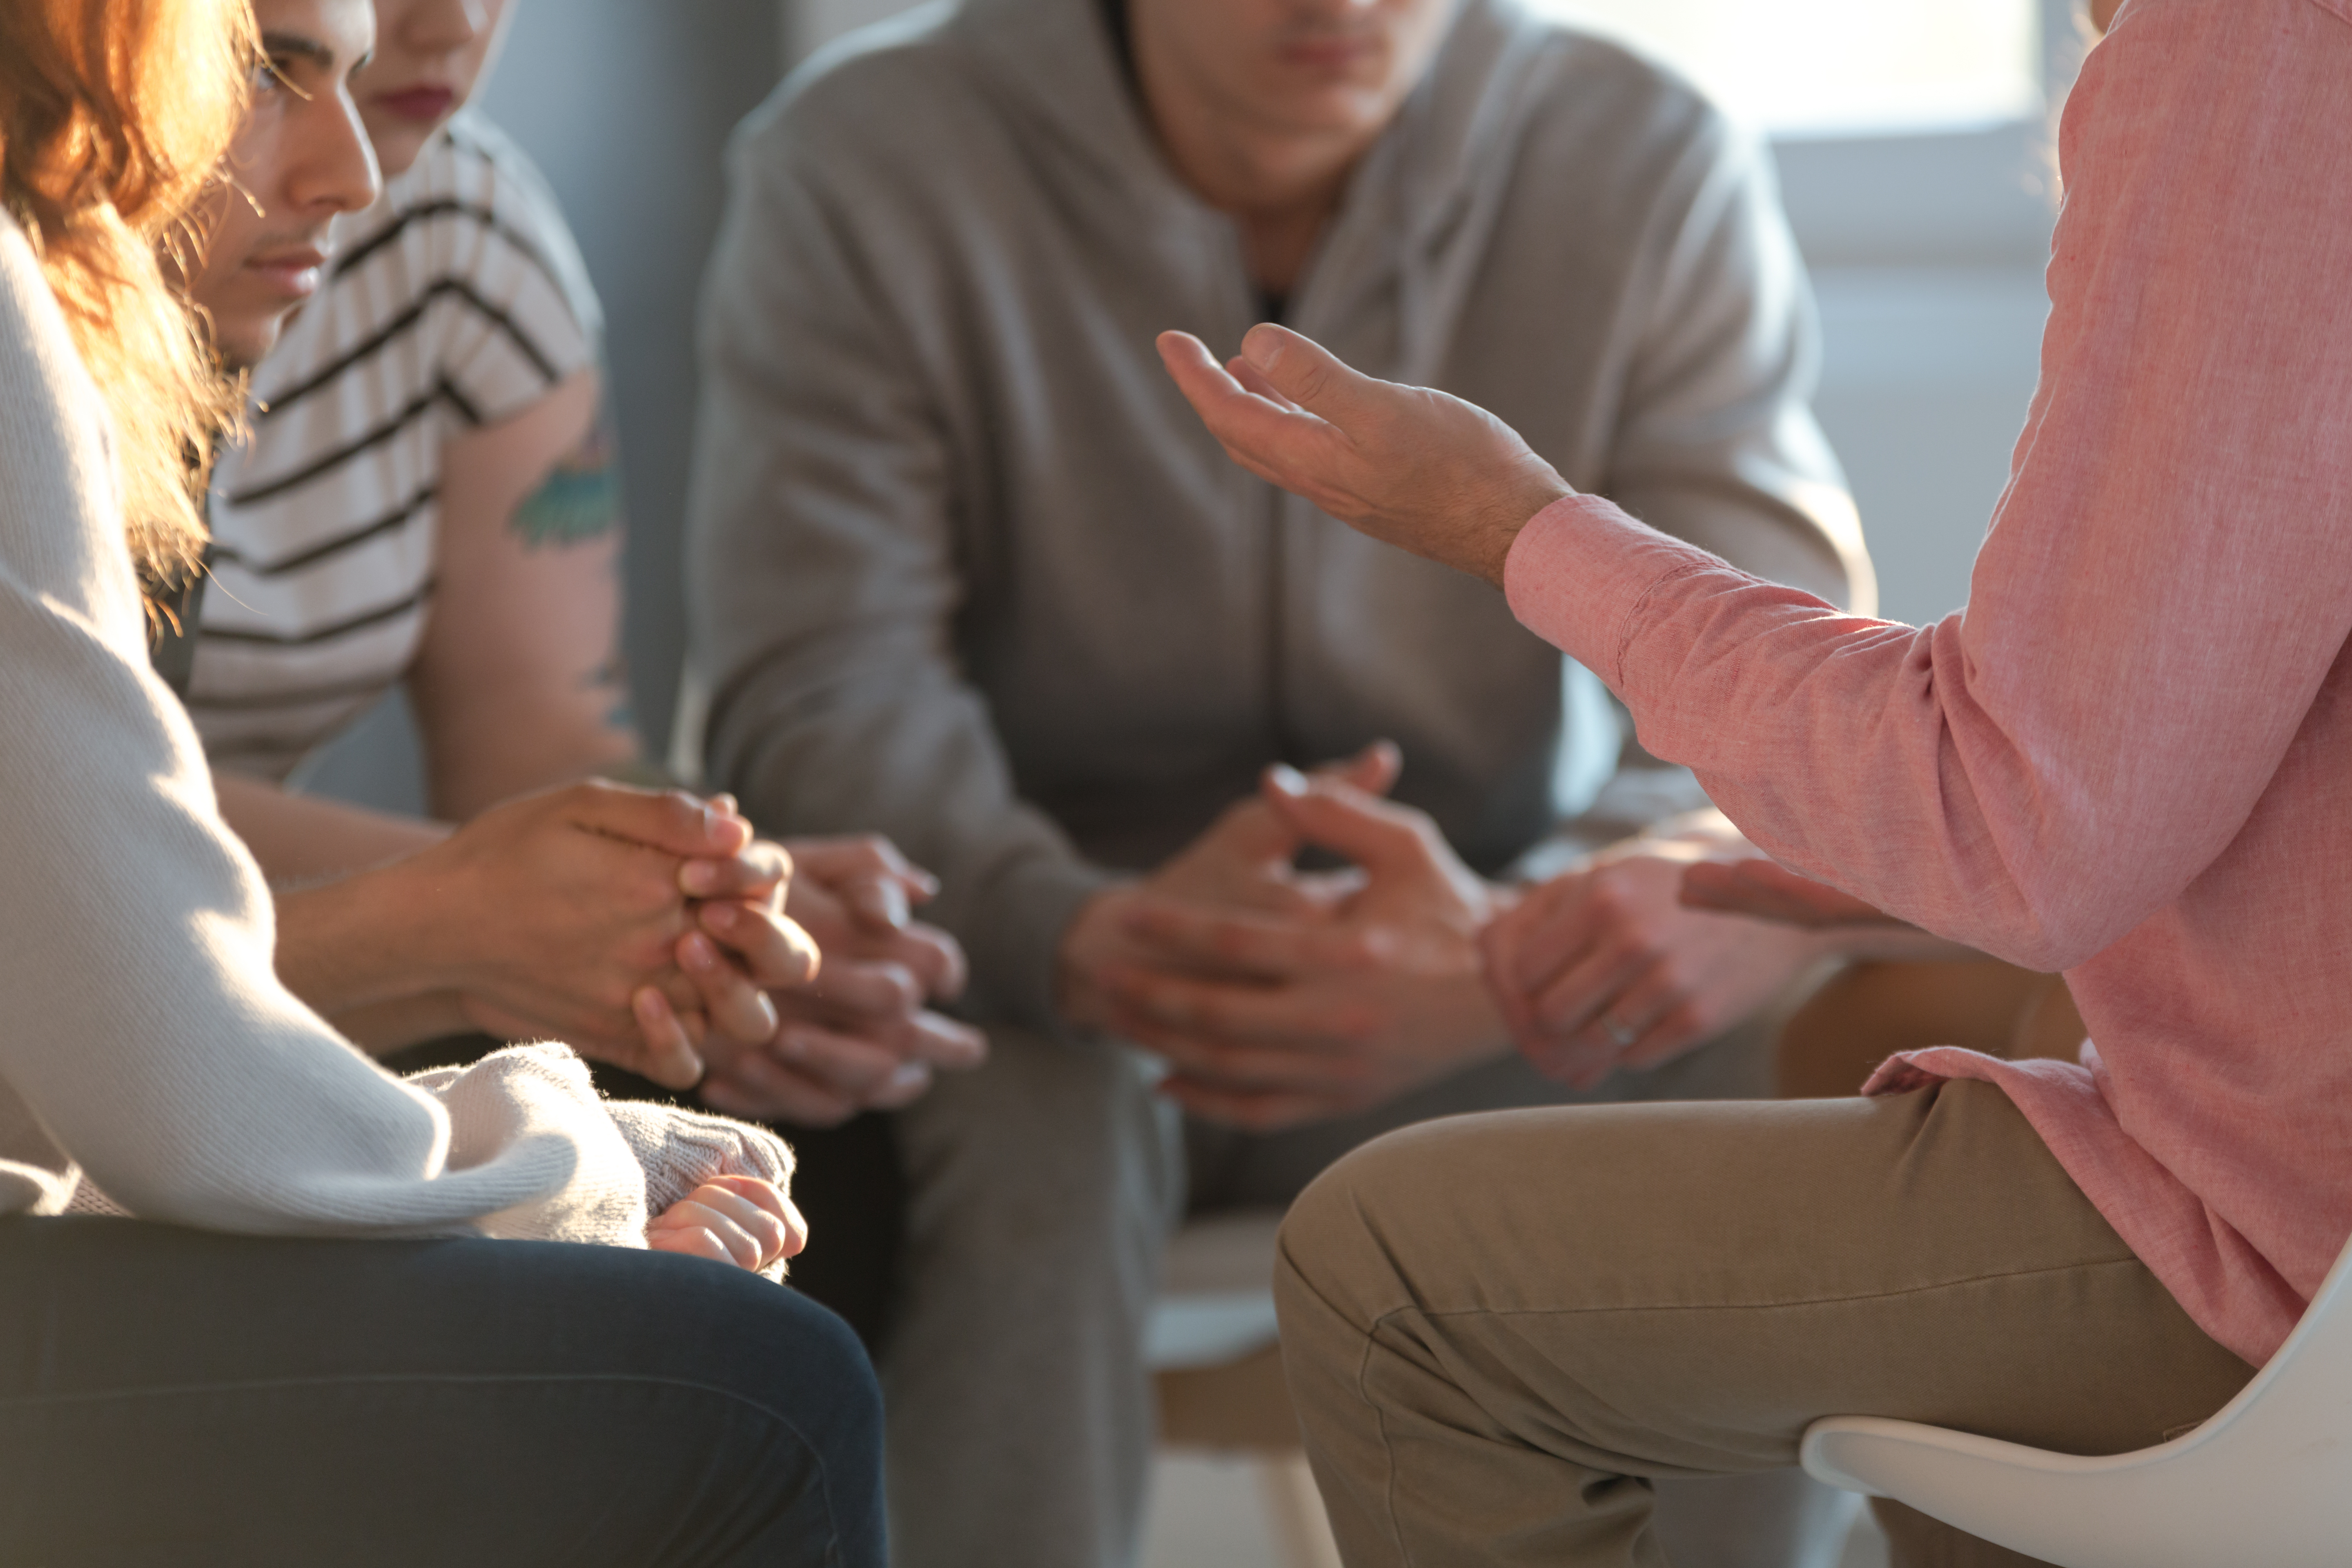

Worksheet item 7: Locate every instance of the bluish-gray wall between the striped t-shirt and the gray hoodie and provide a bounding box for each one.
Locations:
[306,0,783,811]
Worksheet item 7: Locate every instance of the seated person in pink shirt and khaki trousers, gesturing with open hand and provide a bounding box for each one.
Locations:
[1162,0,2352,1568]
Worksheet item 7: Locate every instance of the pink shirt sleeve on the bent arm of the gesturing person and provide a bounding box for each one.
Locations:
[1508,0,2352,969]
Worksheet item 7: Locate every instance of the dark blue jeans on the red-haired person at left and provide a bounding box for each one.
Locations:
[0,1218,884,1568]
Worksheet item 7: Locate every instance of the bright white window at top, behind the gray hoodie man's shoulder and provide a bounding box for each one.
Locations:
[1531,0,2042,136]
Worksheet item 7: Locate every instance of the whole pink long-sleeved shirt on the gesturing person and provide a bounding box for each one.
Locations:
[1508,0,2352,1363]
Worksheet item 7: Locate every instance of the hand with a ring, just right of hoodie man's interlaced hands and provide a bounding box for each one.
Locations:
[1482,818,1830,1089]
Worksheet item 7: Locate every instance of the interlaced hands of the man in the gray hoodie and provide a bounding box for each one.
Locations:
[1061,745,1508,1131]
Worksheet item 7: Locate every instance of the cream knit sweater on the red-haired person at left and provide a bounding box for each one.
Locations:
[0,214,790,1246]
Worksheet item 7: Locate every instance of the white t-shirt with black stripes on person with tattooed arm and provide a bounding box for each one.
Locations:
[188,115,597,778]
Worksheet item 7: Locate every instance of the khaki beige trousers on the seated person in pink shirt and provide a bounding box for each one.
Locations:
[1275,1084,2251,1568]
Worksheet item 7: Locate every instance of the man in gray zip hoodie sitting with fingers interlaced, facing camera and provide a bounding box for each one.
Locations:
[689,0,1870,1568]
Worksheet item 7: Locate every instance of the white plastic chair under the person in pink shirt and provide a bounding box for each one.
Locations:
[1799,1244,2352,1568]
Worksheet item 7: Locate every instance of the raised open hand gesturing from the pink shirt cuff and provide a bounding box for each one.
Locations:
[1160,324,1576,583]
